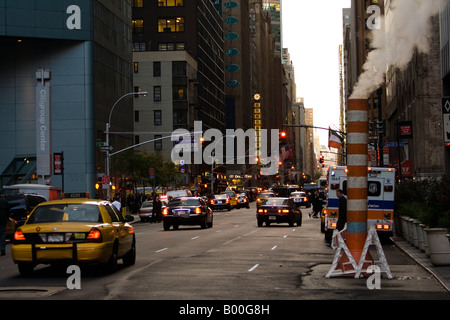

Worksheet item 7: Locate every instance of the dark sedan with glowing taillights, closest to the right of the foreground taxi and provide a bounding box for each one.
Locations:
[163,197,213,230]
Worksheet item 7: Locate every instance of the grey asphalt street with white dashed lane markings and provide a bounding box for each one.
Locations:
[0,203,449,301]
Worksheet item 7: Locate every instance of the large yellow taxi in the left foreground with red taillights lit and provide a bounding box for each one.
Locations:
[11,199,136,275]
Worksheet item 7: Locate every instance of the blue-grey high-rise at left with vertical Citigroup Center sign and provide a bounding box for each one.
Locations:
[0,0,133,197]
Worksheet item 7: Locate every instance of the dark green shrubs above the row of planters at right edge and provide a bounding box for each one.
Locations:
[395,175,450,229]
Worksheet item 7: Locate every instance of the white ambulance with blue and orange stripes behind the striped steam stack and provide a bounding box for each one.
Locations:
[321,166,395,240]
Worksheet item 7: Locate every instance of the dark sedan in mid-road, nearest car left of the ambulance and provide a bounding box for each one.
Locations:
[256,198,302,227]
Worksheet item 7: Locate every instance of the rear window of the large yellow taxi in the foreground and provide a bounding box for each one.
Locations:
[27,204,102,224]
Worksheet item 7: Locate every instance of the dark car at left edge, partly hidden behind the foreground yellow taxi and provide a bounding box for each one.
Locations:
[4,193,47,226]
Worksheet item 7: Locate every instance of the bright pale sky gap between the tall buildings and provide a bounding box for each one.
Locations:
[282,0,351,146]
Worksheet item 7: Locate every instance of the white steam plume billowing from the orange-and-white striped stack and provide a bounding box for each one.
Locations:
[351,0,444,99]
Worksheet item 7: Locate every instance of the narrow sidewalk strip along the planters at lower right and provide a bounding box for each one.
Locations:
[392,236,450,292]
